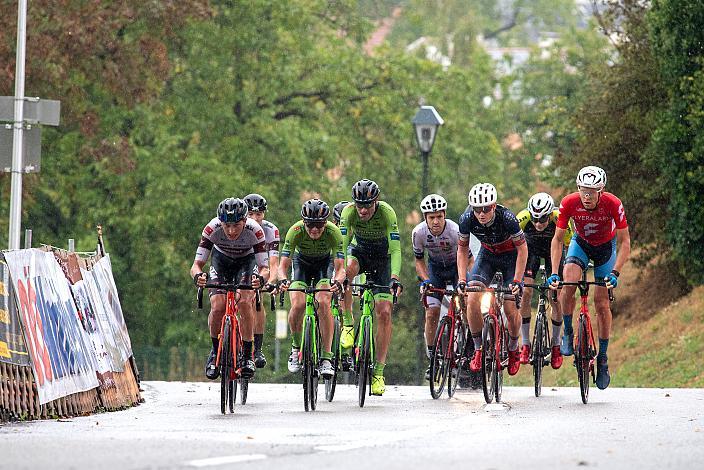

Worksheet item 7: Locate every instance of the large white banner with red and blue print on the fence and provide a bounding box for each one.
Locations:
[5,249,99,404]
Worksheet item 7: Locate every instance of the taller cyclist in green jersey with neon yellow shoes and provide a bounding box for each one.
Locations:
[340,179,402,395]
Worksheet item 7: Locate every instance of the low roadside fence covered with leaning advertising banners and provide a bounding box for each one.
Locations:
[0,233,142,421]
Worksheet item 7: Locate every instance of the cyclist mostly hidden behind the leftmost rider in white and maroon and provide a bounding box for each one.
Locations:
[244,193,281,369]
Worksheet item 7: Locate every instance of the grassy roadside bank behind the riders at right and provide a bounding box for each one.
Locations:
[504,286,704,388]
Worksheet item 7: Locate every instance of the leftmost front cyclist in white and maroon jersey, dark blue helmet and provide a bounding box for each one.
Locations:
[191,198,269,380]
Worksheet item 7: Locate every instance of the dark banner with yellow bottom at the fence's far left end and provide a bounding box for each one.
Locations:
[0,261,29,366]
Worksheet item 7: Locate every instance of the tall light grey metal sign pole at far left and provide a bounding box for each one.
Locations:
[8,0,27,250]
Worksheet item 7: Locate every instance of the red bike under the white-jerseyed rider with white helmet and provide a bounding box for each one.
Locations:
[422,287,467,399]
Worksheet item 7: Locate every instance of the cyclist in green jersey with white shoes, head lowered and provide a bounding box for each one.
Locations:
[279,199,345,378]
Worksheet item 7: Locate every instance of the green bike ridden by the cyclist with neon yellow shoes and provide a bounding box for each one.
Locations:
[350,281,397,408]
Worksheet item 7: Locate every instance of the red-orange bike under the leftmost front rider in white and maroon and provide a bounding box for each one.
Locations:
[198,283,261,414]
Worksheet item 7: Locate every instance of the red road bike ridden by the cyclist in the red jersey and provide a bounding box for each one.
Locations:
[553,264,614,405]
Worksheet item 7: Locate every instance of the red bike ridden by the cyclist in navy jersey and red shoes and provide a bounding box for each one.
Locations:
[465,273,520,403]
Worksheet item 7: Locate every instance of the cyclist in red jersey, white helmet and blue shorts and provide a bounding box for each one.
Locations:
[548,166,631,390]
